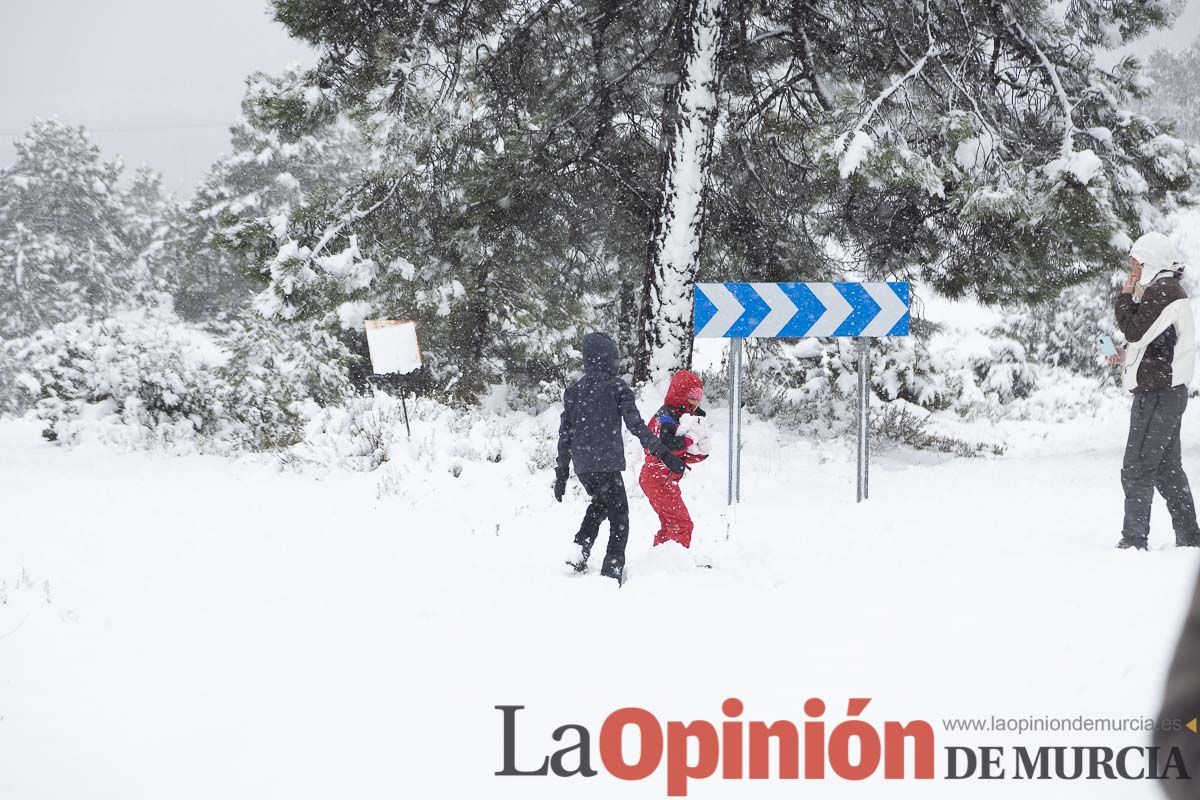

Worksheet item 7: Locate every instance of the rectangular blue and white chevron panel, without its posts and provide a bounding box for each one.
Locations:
[694,282,908,338]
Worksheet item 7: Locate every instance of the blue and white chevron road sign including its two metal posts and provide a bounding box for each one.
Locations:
[692,282,908,515]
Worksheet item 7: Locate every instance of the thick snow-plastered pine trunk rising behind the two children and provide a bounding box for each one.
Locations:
[634,0,726,381]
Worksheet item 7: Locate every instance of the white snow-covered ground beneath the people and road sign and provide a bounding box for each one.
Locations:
[0,383,1200,800]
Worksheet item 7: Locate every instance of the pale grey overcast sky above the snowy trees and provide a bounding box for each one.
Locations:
[0,0,1200,194]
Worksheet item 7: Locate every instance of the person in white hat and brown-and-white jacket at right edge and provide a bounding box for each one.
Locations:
[1116,233,1200,549]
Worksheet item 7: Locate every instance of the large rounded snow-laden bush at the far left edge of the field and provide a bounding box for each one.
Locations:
[7,313,223,445]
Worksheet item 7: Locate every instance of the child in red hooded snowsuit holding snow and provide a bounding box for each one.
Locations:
[637,369,708,547]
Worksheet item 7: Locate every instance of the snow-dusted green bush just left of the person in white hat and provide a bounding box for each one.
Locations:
[1003,277,1122,381]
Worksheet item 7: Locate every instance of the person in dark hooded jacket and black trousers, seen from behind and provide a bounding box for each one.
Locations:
[554,333,684,582]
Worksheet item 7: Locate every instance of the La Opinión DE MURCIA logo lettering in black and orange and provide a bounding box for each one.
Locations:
[494,697,1190,798]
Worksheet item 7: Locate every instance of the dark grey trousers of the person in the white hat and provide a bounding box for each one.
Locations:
[1121,386,1200,545]
